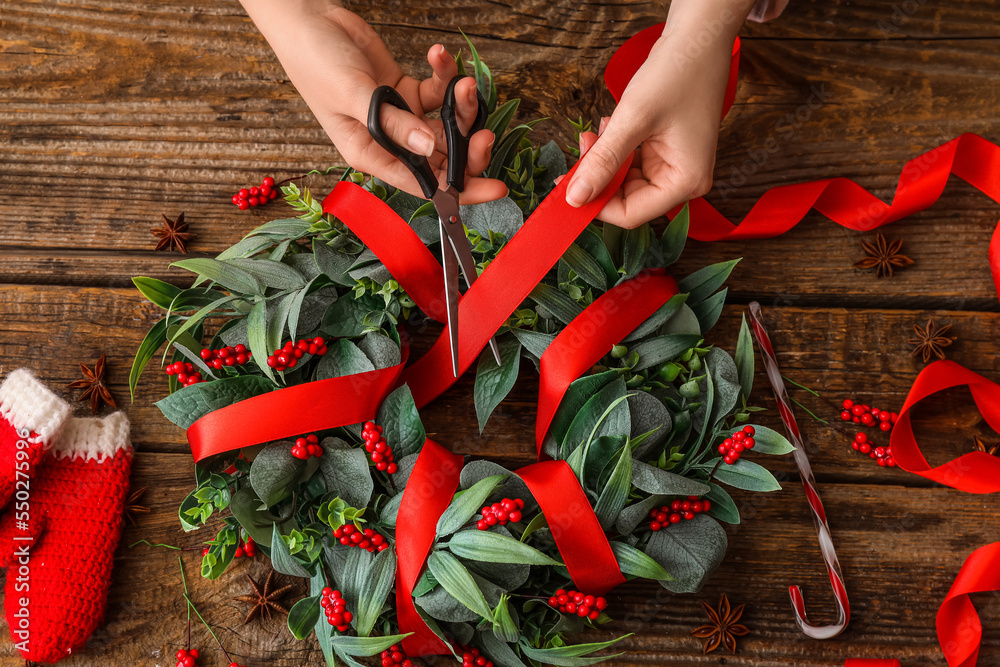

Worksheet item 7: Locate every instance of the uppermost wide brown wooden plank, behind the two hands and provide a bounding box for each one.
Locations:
[0,0,1000,309]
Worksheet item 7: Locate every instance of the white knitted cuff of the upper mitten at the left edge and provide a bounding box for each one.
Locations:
[0,368,72,443]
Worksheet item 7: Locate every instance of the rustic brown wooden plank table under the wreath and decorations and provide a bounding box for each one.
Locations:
[0,0,1000,667]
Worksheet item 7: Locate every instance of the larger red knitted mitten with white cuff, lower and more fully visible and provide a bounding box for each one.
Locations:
[0,412,132,662]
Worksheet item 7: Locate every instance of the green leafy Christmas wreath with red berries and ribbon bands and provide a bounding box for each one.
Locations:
[130,35,792,667]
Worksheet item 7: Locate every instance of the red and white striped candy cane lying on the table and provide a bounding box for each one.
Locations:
[750,301,851,639]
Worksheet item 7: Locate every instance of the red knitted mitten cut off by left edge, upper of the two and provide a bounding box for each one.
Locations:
[0,368,71,507]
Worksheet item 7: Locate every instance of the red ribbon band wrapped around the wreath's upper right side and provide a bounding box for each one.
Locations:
[535,269,677,459]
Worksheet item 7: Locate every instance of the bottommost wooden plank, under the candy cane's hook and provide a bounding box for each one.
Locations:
[0,450,1000,667]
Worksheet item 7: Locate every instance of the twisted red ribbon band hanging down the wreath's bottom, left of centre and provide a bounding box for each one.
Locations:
[396,440,462,657]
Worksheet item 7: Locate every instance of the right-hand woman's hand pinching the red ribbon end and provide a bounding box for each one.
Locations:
[566,0,753,227]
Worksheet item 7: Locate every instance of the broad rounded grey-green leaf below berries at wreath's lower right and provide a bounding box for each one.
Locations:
[646,514,728,593]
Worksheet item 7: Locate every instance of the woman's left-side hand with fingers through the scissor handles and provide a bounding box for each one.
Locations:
[243,0,507,203]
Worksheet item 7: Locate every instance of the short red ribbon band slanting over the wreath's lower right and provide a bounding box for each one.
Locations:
[517,461,625,595]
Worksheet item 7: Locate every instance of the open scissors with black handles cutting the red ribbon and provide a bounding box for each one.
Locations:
[368,75,500,377]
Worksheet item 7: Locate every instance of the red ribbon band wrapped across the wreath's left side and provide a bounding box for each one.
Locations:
[187,339,409,462]
